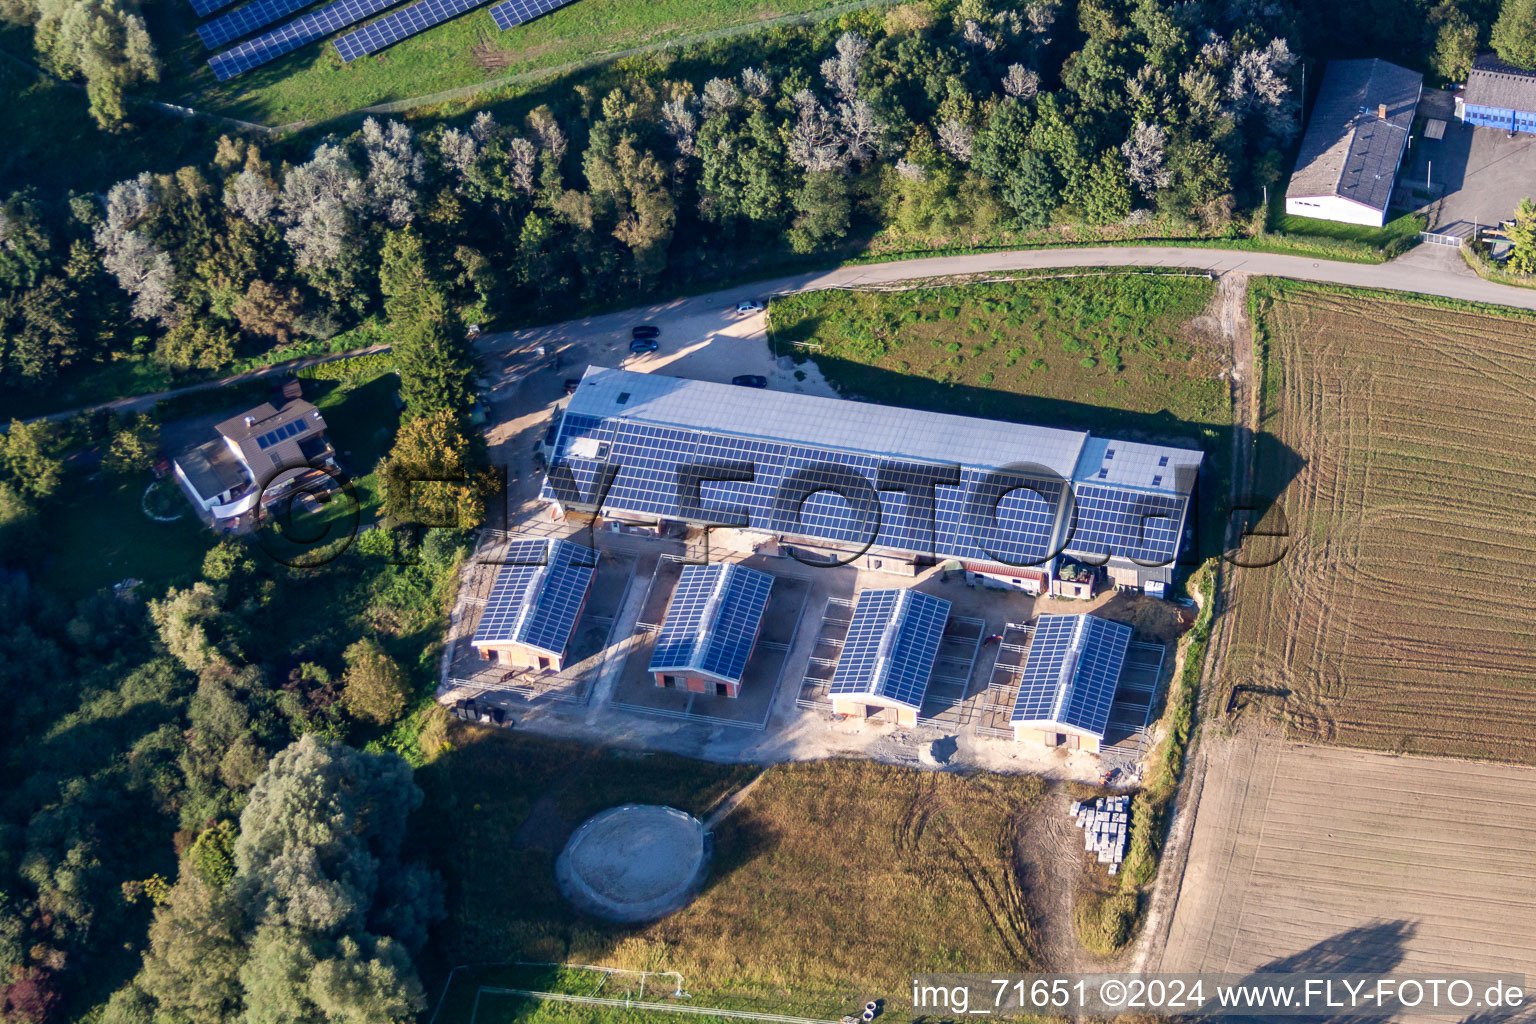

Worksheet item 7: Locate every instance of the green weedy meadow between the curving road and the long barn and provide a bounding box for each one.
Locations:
[768,270,1232,551]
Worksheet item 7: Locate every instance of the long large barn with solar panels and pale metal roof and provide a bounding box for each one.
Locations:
[544,367,1203,597]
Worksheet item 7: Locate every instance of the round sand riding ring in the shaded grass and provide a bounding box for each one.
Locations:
[554,803,710,924]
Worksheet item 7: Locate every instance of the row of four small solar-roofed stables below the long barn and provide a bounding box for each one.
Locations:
[472,539,1130,751]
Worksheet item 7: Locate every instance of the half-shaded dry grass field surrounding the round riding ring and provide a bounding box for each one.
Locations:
[415,728,1043,1024]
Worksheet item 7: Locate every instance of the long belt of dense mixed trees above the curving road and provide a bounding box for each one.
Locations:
[0,0,1298,405]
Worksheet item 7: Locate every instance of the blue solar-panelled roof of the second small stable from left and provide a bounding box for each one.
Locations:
[650,562,773,682]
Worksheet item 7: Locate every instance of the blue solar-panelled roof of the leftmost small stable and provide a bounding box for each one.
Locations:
[472,540,594,656]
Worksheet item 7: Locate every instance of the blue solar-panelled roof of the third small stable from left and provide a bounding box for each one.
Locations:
[829,590,949,709]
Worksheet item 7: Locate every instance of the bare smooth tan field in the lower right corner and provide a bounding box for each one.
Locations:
[1149,729,1536,976]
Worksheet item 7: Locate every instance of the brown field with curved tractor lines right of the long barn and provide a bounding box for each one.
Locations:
[1218,282,1536,763]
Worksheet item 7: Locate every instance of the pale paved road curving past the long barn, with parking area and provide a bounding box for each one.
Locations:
[21,246,1536,419]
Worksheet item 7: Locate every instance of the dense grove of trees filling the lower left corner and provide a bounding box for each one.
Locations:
[0,531,459,1024]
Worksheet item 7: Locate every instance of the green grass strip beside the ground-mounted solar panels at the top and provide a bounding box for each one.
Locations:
[152,0,872,124]
